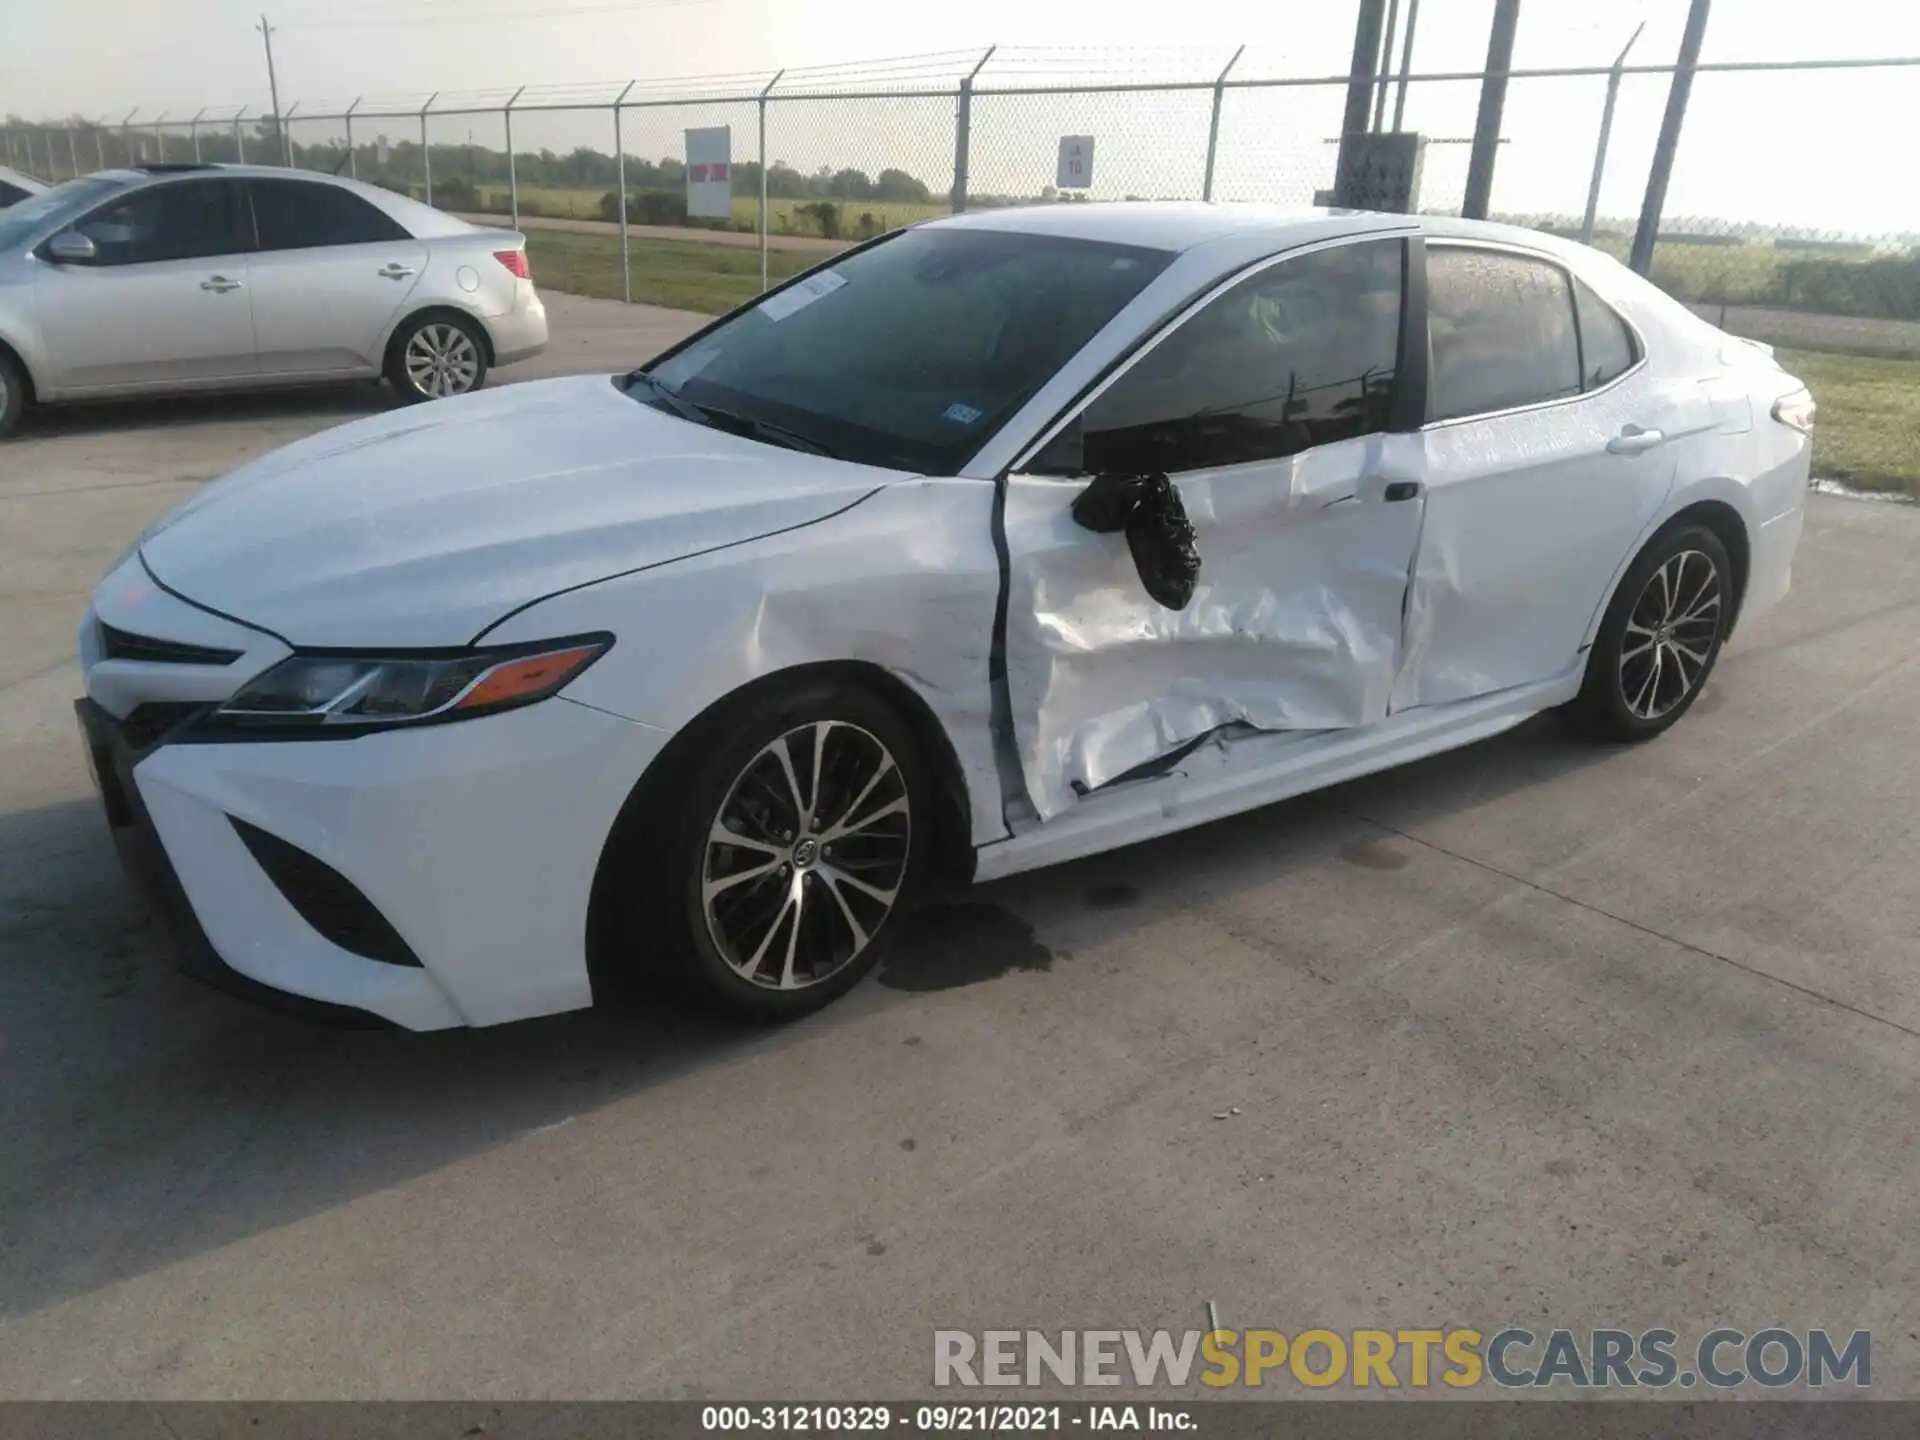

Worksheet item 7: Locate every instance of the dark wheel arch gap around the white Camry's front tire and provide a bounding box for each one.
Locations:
[586,660,975,996]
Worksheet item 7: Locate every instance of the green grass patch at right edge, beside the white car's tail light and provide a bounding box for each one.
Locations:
[1778,349,1920,499]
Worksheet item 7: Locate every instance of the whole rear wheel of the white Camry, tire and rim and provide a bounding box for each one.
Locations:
[1569,524,1734,741]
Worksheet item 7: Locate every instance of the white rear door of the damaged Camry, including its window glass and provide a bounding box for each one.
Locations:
[1392,238,1707,710]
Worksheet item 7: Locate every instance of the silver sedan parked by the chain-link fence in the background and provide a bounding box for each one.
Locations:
[0,165,547,436]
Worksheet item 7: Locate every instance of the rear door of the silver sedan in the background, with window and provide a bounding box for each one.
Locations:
[248,179,426,376]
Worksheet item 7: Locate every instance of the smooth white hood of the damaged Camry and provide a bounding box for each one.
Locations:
[140,376,897,647]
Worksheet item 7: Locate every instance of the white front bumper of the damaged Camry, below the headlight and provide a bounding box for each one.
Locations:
[77,699,666,1029]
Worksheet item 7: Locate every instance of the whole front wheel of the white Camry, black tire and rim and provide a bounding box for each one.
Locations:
[634,682,933,1020]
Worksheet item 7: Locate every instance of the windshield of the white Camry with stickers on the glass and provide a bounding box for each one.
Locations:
[630,227,1173,474]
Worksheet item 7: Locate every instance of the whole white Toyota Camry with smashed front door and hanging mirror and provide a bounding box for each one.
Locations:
[79,204,1812,1029]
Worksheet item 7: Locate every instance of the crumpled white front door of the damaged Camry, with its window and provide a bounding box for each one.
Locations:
[1004,238,1425,818]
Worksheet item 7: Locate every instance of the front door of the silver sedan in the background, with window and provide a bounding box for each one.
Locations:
[35,177,253,394]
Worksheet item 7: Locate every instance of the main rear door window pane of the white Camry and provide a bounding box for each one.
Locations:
[1427,246,1580,420]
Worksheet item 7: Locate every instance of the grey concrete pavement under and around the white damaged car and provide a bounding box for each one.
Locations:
[0,288,1920,1400]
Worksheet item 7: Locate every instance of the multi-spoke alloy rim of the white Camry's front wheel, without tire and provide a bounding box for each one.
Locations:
[701,720,914,991]
